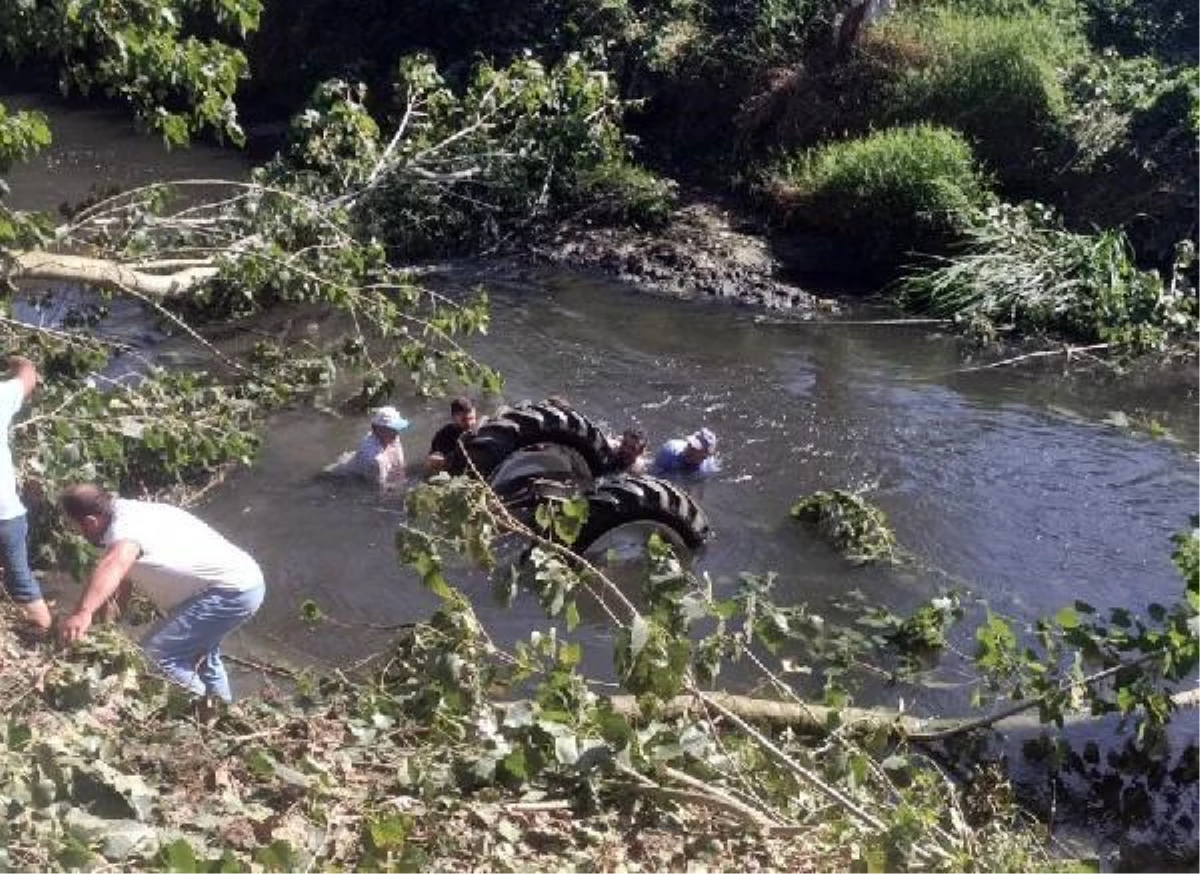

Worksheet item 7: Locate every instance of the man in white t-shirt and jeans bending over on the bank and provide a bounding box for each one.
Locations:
[59,485,265,701]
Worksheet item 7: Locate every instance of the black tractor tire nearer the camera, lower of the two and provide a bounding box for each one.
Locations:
[571,473,712,552]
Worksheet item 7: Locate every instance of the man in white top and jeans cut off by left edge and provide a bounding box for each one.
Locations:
[0,355,50,631]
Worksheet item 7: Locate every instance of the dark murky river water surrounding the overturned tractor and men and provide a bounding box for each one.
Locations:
[10,95,1200,710]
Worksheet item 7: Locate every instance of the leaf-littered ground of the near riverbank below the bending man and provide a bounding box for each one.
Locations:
[0,606,853,872]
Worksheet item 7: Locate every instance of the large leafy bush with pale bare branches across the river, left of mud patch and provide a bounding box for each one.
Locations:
[264,55,671,259]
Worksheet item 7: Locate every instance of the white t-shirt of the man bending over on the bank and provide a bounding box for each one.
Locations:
[104,498,263,610]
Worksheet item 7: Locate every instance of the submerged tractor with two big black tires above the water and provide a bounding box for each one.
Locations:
[451,401,712,556]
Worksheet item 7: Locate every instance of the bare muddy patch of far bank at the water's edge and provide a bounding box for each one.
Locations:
[521,196,838,318]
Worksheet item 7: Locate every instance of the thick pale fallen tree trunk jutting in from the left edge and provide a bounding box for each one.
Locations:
[0,251,217,300]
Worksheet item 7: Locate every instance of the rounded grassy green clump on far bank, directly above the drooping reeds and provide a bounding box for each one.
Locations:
[768,125,991,273]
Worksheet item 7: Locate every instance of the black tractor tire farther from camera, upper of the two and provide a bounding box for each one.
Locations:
[451,403,613,479]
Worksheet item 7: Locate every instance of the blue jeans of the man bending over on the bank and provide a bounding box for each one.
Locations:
[142,586,265,701]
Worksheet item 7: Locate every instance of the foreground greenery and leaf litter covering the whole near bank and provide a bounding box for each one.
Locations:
[9,480,1200,872]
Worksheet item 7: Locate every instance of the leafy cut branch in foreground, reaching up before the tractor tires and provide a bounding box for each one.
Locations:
[397,481,1041,861]
